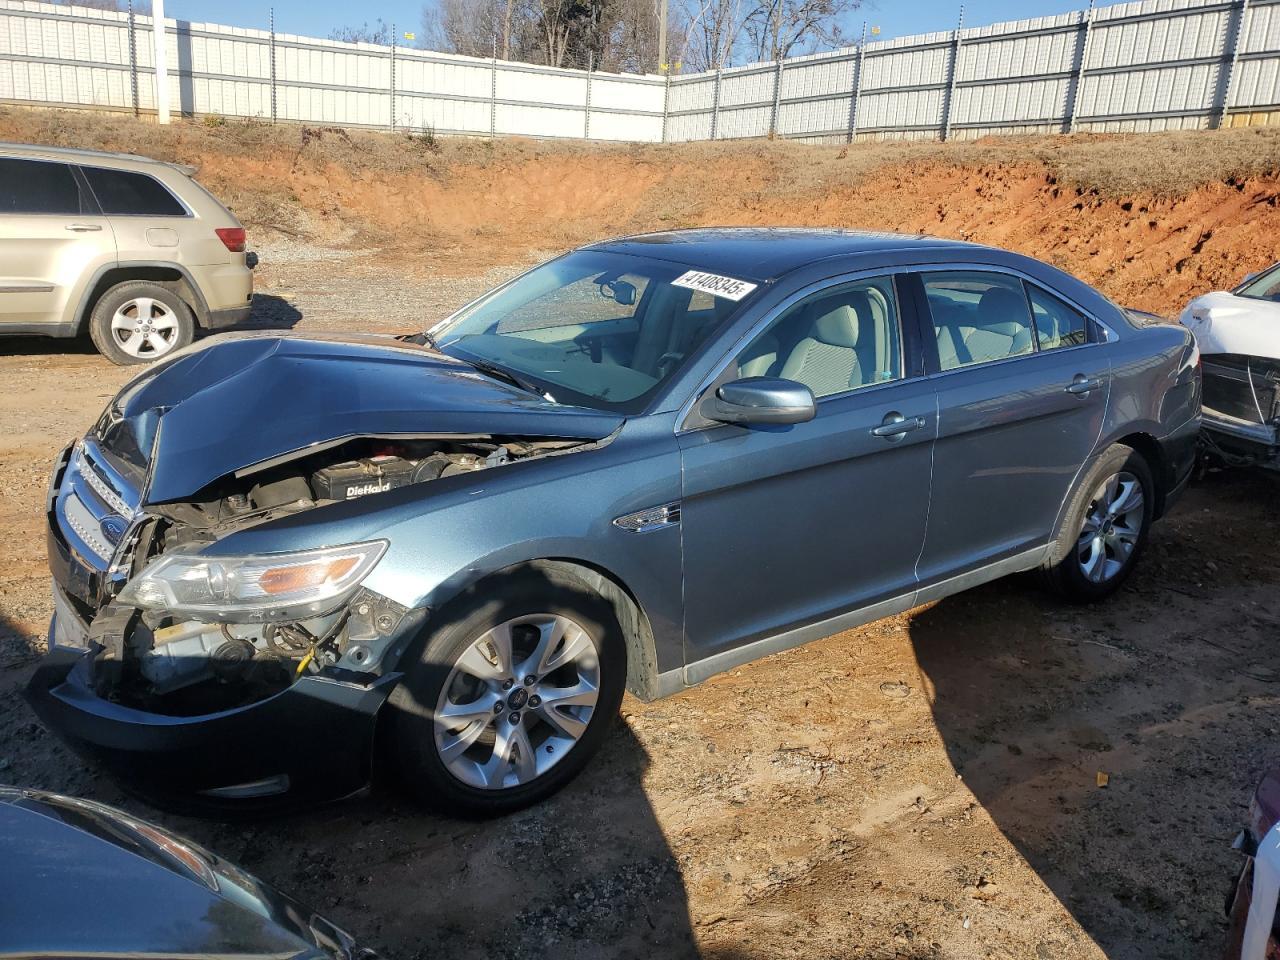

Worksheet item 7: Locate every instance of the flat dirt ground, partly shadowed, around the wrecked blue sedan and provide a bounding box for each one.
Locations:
[0,242,1280,960]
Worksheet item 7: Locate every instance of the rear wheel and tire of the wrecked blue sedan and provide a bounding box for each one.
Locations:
[1041,443,1156,603]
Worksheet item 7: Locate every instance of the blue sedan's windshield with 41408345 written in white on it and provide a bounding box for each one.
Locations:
[433,251,755,413]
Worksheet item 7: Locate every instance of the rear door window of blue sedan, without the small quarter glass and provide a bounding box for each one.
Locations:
[922,270,1036,370]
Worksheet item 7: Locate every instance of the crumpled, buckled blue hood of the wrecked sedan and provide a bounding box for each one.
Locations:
[112,335,622,503]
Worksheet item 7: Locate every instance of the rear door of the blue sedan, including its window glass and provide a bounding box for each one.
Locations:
[909,269,1111,586]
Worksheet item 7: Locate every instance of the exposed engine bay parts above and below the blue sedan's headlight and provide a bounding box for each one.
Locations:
[90,438,584,716]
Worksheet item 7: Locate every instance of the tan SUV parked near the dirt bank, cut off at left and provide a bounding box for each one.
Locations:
[0,143,256,364]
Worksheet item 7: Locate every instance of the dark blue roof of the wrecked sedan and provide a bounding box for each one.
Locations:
[586,227,989,280]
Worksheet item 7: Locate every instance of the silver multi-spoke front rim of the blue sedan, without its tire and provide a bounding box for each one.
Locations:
[434,613,600,790]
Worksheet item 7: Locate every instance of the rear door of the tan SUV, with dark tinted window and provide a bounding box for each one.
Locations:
[0,156,115,329]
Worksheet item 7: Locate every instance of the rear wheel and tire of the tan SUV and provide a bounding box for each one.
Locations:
[88,280,196,366]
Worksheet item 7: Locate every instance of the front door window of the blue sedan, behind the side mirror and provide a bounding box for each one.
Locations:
[737,276,902,397]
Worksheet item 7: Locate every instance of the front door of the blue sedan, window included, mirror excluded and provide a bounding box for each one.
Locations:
[680,276,937,680]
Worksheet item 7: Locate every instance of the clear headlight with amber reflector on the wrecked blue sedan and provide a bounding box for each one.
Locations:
[119,540,387,622]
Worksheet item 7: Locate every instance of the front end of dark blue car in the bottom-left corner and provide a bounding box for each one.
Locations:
[0,787,355,960]
